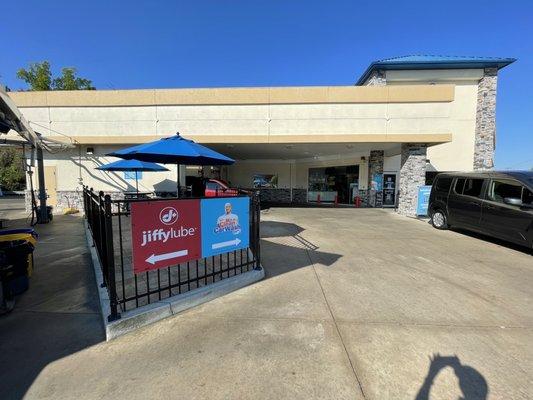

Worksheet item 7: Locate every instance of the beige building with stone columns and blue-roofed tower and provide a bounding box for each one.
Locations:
[9,56,514,214]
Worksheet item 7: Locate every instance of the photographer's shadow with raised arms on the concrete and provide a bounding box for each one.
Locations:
[415,353,489,400]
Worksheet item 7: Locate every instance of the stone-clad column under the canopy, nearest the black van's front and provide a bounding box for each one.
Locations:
[398,143,427,217]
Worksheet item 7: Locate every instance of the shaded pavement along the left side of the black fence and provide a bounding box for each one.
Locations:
[0,215,105,400]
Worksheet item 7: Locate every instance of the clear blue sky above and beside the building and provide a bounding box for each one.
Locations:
[0,0,533,168]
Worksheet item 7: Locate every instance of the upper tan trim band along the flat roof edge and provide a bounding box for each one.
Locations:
[9,84,455,107]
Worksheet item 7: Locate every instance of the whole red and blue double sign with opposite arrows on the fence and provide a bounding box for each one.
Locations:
[131,197,250,274]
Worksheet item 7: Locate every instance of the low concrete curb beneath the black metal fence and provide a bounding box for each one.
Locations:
[83,220,265,341]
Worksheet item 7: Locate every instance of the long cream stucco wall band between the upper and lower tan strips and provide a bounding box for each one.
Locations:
[16,99,454,143]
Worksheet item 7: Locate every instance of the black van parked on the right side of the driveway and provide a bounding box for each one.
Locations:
[428,171,533,249]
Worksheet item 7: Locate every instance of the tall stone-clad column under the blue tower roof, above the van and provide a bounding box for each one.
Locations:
[474,68,498,170]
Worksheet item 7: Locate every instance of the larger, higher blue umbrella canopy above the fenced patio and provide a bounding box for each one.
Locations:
[108,132,235,165]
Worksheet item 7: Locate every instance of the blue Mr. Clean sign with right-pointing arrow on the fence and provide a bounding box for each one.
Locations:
[200,197,250,257]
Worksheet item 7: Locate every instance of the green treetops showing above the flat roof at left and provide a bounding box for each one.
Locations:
[17,61,95,90]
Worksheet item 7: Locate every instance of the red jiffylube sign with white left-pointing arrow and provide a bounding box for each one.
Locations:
[131,200,202,274]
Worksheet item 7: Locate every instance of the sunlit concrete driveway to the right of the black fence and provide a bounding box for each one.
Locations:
[14,208,533,400]
